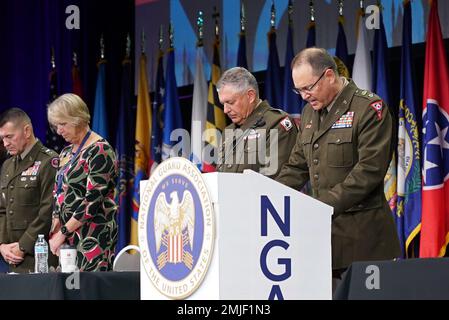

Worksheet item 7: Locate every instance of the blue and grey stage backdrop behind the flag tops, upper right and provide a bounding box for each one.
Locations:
[135,0,449,86]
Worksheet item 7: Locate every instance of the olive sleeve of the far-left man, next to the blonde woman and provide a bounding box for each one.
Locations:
[19,155,57,254]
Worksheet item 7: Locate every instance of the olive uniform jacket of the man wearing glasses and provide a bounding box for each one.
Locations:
[276,80,400,269]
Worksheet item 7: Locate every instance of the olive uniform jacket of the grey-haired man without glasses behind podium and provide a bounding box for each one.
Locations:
[217,101,298,177]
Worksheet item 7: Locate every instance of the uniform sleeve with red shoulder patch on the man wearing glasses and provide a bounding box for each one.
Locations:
[318,101,393,214]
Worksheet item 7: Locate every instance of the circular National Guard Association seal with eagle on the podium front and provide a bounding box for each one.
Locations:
[138,157,215,299]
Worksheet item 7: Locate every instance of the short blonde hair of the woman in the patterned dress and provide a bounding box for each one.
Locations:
[47,93,90,127]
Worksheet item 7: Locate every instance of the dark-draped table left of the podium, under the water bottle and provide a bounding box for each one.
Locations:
[0,272,140,300]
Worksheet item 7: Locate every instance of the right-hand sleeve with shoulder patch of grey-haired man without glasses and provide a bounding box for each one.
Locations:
[261,117,298,179]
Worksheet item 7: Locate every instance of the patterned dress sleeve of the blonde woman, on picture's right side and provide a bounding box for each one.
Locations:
[73,144,117,223]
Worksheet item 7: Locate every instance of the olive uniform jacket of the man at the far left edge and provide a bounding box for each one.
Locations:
[0,141,58,272]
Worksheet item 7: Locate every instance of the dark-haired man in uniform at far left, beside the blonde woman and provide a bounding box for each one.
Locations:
[0,108,58,272]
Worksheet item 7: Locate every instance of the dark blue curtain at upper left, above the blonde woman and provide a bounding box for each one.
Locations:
[0,0,134,146]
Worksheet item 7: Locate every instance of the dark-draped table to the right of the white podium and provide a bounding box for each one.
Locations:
[334,258,449,300]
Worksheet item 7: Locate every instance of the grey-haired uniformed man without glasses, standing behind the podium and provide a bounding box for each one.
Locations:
[217,67,298,178]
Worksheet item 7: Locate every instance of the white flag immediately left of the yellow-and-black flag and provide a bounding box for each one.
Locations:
[191,45,207,169]
